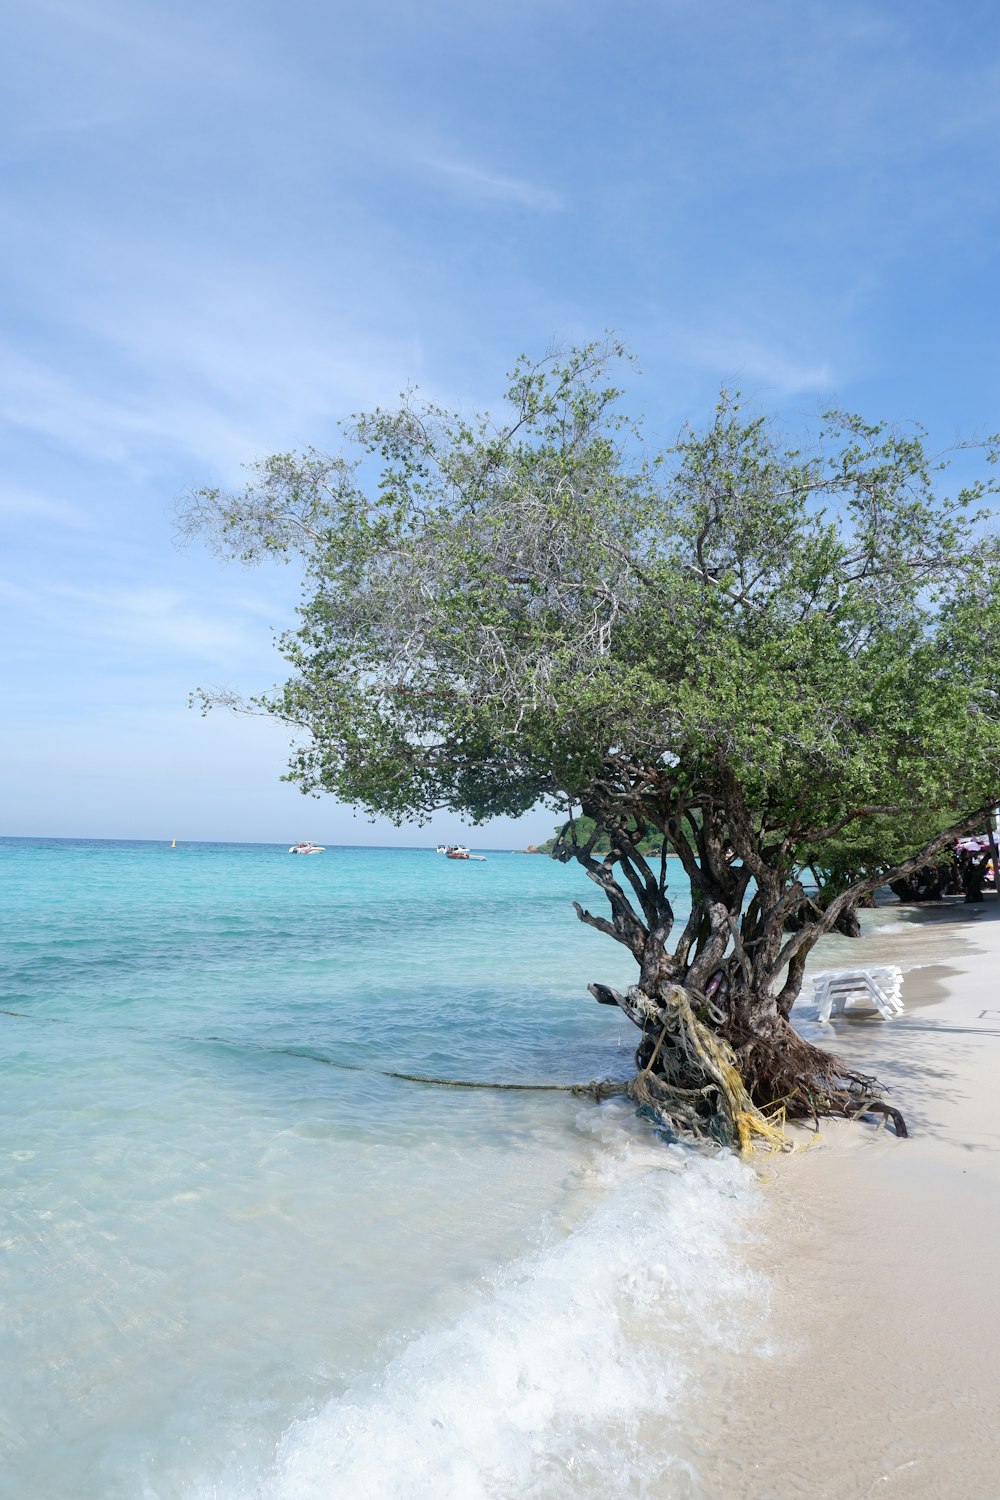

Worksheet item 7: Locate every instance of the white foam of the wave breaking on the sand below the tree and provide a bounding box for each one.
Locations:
[217,1106,766,1500]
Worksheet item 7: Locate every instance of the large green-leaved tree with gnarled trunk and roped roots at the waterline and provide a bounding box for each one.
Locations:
[181,342,1000,1145]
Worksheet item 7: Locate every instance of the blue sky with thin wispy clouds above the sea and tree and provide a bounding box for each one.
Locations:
[0,0,1000,846]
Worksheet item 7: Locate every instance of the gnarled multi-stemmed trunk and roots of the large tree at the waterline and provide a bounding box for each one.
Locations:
[553,810,981,1151]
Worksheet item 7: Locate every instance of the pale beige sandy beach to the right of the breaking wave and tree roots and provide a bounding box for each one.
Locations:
[706,900,1000,1500]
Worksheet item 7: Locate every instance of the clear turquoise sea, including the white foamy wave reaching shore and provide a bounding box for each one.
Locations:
[0,840,757,1500]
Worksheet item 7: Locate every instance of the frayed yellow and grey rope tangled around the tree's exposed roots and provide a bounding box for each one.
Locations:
[628,986,795,1157]
